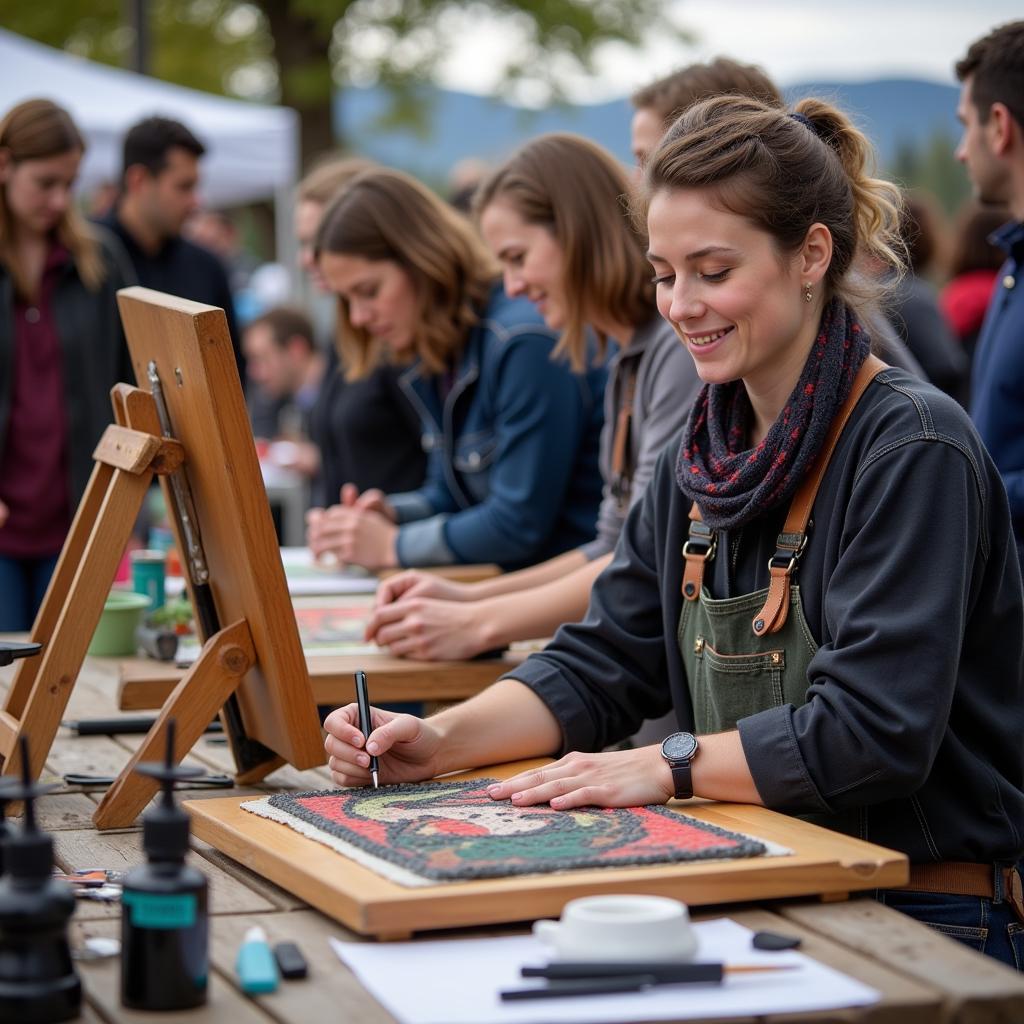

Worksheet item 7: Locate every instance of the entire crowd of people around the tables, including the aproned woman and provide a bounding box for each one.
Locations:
[0,22,1024,969]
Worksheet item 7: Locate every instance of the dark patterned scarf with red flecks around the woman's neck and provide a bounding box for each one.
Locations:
[676,299,869,529]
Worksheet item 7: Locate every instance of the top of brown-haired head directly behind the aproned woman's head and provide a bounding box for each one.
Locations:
[630,57,782,168]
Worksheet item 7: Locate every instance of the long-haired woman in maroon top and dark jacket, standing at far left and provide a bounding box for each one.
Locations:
[0,99,133,632]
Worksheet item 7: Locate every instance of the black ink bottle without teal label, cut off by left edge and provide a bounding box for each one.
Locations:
[0,736,82,1024]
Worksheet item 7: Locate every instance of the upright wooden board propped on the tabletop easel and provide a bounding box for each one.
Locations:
[112,288,325,768]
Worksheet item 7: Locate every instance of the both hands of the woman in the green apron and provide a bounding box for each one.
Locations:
[324,703,675,810]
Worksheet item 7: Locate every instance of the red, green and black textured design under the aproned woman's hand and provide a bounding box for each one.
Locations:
[260,778,766,882]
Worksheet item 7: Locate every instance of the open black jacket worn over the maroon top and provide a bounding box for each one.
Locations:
[0,224,135,505]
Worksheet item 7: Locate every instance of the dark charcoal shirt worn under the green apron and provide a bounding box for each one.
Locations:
[511,370,1024,862]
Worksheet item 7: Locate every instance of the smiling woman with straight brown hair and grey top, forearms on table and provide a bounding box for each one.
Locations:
[368,134,699,659]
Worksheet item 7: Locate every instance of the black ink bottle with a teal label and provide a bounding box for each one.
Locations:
[121,720,209,1011]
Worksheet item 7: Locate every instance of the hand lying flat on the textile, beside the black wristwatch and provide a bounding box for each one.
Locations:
[487,745,676,811]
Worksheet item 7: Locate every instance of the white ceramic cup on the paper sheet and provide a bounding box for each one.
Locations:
[534,896,697,961]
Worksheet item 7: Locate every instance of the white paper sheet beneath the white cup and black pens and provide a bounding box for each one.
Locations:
[330,918,882,1024]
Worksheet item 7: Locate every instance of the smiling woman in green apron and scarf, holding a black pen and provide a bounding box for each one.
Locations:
[326,97,1024,966]
